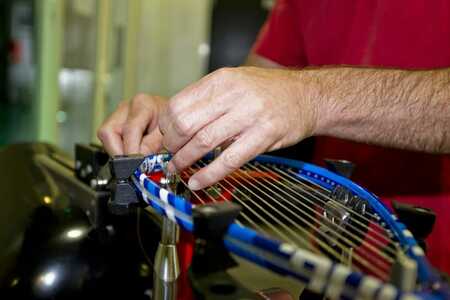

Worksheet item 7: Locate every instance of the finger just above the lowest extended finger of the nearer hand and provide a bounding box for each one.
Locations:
[167,112,249,172]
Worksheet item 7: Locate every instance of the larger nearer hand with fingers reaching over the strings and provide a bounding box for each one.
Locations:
[159,67,316,190]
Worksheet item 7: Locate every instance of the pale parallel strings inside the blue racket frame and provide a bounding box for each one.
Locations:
[173,160,398,281]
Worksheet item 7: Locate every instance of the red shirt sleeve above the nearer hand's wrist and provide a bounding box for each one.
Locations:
[252,0,306,67]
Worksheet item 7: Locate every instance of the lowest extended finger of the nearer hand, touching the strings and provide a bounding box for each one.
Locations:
[189,129,271,190]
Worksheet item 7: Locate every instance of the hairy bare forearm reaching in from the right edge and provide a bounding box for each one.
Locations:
[299,67,450,153]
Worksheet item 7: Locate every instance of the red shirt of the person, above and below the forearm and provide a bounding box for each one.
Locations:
[253,0,450,272]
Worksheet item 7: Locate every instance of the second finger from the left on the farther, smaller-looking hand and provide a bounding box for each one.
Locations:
[122,95,157,154]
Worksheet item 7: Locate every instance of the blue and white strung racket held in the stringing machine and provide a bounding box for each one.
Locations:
[132,154,450,299]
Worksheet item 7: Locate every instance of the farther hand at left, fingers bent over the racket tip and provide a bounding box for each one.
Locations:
[97,94,167,156]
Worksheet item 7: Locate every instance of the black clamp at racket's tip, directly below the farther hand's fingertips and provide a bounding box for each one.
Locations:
[108,155,145,215]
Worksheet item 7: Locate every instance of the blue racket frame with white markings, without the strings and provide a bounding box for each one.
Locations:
[132,154,450,299]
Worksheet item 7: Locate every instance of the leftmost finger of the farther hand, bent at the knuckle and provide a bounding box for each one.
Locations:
[97,101,128,156]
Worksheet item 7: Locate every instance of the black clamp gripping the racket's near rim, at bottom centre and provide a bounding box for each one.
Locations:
[189,201,257,300]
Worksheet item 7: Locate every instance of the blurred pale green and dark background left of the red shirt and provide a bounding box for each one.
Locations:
[0,0,273,154]
